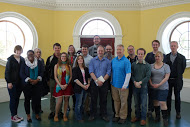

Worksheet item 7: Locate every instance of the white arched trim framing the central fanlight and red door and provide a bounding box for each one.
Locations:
[73,11,123,54]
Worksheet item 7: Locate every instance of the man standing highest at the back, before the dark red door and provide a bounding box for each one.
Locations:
[89,35,101,57]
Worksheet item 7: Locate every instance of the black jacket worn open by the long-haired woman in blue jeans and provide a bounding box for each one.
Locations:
[72,67,90,94]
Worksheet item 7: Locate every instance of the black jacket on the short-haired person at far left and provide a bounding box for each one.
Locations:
[5,55,24,85]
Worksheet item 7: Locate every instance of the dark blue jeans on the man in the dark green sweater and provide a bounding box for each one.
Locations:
[133,87,147,120]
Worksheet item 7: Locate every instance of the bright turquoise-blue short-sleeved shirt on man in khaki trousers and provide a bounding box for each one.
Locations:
[112,55,131,88]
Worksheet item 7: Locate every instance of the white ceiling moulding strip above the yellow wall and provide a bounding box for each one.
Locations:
[0,0,190,10]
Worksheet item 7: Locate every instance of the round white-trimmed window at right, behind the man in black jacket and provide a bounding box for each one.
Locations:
[157,12,190,67]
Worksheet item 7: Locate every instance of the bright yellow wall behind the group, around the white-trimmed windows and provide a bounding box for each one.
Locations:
[0,3,190,79]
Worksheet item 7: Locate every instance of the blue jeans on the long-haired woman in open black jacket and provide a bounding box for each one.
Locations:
[75,89,87,120]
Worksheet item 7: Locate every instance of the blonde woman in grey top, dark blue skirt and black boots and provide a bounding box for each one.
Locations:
[149,51,170,126]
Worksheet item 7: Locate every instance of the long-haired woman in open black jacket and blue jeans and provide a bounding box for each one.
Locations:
[72,55,90,122]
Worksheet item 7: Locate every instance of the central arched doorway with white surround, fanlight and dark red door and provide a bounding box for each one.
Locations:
[73,11,123,54]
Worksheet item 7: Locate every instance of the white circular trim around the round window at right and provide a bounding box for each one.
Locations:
[157,12,190,68]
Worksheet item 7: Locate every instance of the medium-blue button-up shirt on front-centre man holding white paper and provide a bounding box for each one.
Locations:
[89,56,111,78]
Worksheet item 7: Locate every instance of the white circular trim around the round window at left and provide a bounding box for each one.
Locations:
[0,12,38,66]
